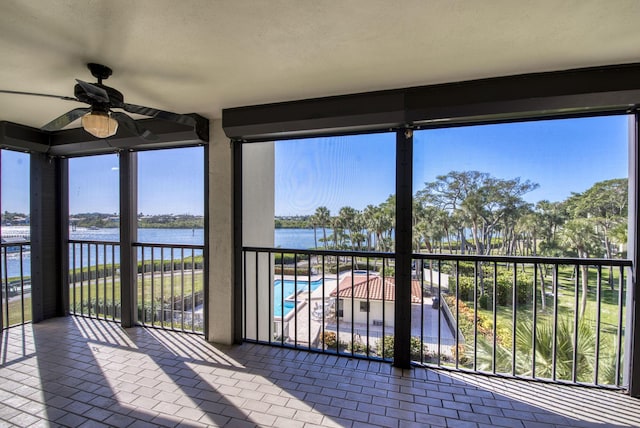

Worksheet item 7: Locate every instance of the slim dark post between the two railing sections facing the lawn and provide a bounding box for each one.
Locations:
[119,151,138,328]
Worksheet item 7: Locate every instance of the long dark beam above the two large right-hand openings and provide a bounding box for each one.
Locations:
[222,63,640,141]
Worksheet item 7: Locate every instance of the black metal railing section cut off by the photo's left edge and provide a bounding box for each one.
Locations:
[0,241,32,329]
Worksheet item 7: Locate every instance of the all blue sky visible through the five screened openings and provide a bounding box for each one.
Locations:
[2,116,628,215]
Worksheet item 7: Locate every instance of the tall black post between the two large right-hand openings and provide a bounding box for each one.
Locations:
[393,129,413,368]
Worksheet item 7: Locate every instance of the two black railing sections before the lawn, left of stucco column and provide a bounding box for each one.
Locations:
[69,240,204,333]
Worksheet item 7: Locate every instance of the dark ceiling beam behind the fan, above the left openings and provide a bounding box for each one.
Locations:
[0,114,209,157]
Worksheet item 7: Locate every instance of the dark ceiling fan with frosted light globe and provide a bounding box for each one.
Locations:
[0,63,196,141]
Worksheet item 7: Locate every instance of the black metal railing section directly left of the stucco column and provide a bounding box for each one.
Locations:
[134,243,204,334]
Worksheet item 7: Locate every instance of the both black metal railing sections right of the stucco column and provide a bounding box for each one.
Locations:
[243,248,631,388]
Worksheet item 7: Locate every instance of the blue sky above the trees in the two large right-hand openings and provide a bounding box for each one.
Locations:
[275,116,628,215]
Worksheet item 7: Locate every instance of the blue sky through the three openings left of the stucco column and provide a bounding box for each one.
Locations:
[2,147,204,215]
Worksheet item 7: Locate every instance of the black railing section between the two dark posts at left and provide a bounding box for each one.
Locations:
[69,240,122,321]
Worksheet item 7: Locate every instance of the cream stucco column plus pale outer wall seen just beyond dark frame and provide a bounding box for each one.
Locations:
[207,126,274,344]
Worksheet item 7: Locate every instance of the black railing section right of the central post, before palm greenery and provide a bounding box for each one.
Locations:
[412,254,631,387]
